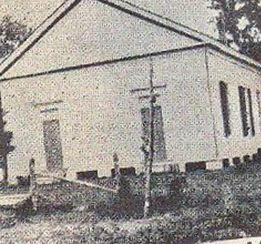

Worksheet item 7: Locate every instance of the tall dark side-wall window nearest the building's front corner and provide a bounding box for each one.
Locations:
[219,81,231,137]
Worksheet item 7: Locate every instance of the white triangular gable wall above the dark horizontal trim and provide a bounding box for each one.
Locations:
[4,0,197,77]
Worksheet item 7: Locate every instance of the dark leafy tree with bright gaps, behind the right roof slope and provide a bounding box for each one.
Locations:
[208,0,261,62]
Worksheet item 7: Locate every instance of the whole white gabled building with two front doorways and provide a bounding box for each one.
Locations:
[0,0,261,179]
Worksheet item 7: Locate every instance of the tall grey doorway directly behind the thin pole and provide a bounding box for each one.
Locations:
[141,106,167,162]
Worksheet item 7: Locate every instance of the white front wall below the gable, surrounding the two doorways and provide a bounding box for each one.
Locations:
[0,48,215,178]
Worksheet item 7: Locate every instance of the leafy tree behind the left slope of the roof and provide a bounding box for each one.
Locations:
[0,16,31,59]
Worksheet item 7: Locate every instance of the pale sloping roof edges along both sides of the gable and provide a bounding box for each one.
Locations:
[0,0,261,76]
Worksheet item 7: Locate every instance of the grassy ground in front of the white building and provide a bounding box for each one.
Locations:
[0,161,261,243]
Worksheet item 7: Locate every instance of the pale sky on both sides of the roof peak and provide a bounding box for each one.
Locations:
[0,0,215,36]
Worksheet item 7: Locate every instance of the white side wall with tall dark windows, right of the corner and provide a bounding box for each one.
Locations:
[207,50,261,166]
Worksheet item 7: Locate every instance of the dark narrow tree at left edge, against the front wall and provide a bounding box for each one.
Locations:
[0,95,15,183]
